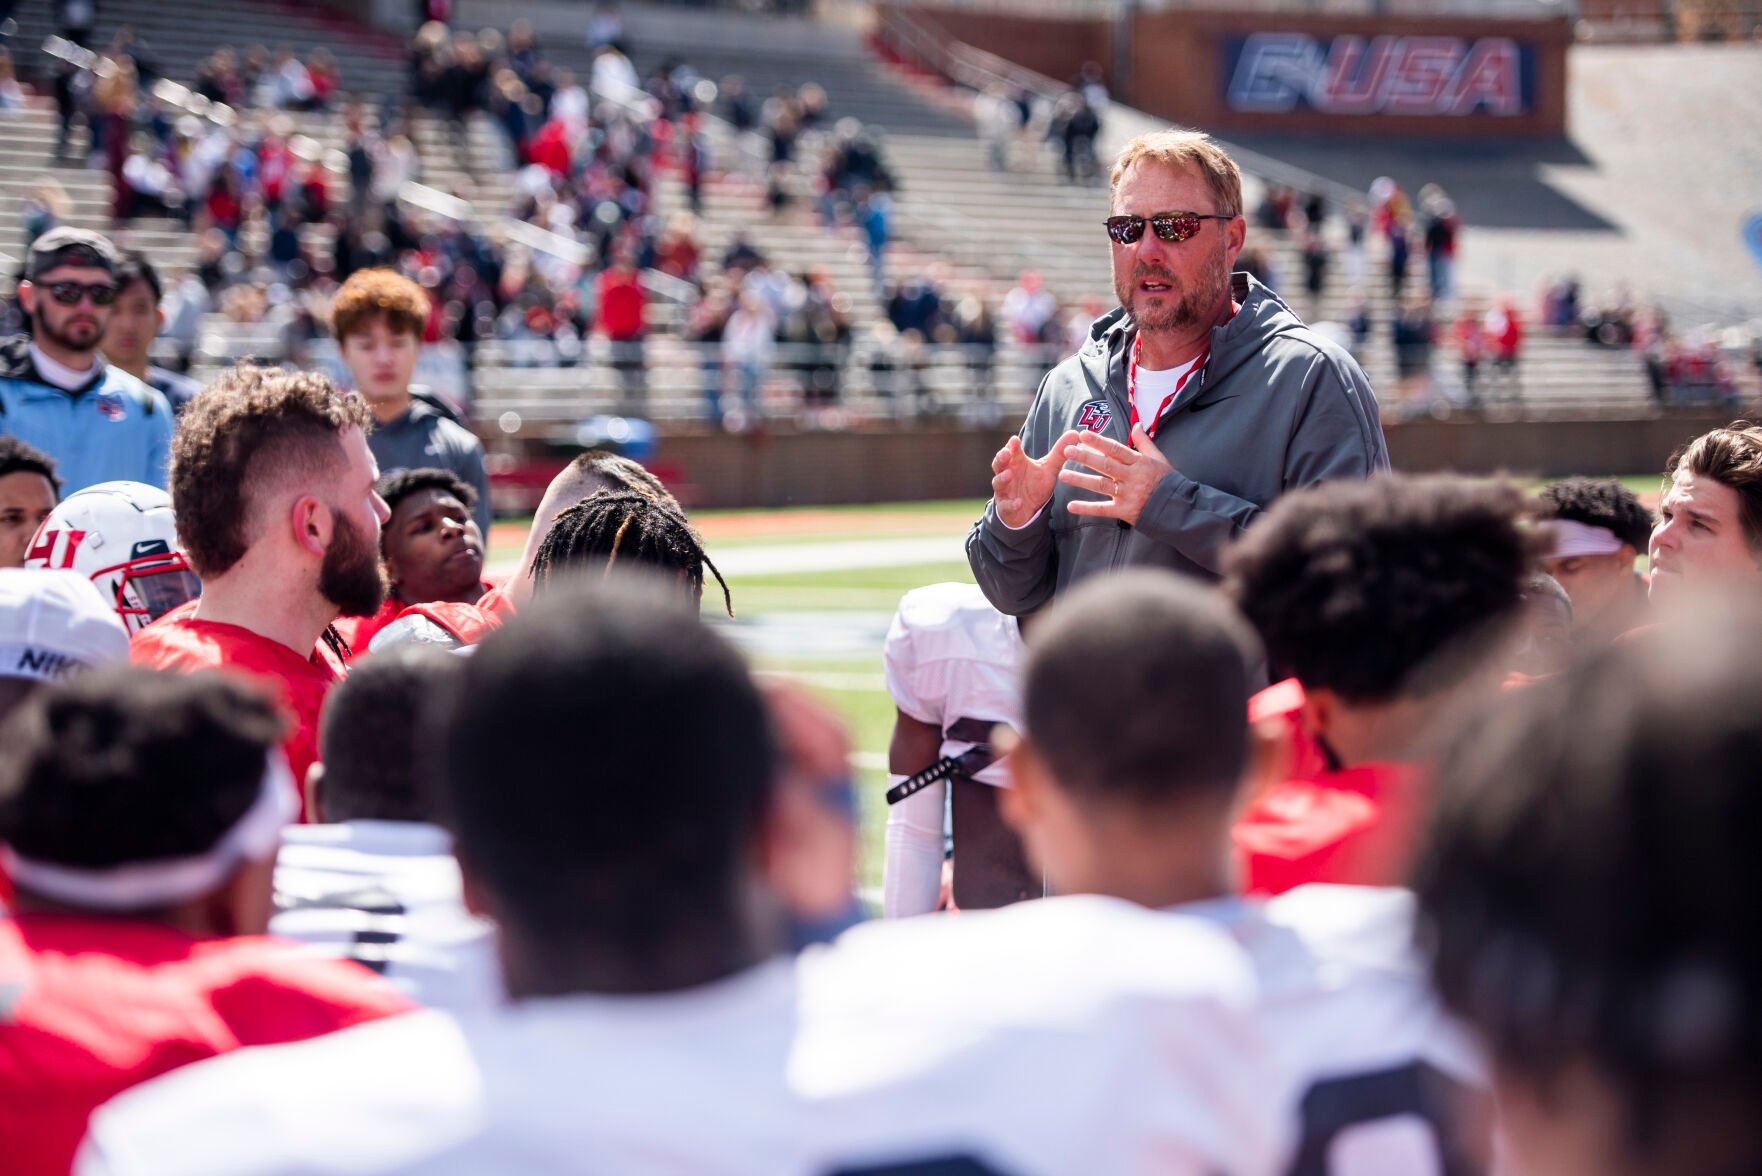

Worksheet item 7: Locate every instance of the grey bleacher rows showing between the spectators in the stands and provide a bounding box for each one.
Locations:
[0,0,1733,425]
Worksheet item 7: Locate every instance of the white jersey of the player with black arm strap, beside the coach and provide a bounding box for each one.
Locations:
[883,584,1022,786]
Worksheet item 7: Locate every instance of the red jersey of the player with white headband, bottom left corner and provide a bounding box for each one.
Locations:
[0,915,411,1176]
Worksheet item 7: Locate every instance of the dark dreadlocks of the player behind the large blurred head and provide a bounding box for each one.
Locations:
[532,490,735,617]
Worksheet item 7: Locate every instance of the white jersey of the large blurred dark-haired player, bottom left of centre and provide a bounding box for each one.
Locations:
[74,959,807,1176]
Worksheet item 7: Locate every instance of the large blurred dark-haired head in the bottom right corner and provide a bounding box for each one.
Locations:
[1415,598,1762,1176]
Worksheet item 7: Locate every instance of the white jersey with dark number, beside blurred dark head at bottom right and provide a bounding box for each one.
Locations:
[1173,885,1487,1176]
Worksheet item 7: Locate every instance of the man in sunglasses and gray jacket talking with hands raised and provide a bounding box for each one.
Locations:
[967,130,1388,615]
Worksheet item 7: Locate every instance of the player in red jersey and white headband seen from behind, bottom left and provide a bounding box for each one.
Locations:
[0,666,409,1176]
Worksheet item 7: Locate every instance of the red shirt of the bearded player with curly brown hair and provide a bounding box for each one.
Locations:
[129,601,349,820]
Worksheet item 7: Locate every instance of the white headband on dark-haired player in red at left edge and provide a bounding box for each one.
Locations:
[0,748,300,912]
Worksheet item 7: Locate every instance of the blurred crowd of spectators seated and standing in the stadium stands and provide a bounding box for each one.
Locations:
[0,5,1736,421]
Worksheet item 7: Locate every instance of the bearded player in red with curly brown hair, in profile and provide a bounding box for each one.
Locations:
[130,365,388,811]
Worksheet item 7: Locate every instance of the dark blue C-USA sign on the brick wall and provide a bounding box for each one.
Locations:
[1223,33,1536,118]
